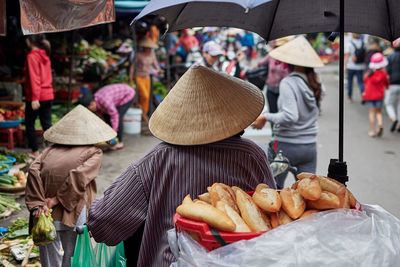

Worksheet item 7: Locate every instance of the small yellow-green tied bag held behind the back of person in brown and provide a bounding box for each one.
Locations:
[32,212,57,246]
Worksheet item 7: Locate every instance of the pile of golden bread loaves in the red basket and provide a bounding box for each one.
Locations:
[176,173,357,233]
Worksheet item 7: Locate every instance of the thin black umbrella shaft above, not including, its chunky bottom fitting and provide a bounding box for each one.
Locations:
[339,0,344,162]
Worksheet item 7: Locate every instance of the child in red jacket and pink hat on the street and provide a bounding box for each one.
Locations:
[363,53,389,137]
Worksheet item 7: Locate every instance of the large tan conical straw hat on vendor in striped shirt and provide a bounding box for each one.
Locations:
[149,65,264,145]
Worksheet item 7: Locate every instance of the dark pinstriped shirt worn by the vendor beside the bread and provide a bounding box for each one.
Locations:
[88,137,275,267]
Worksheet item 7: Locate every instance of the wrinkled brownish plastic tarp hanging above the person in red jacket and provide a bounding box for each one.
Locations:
[19,0,115,34]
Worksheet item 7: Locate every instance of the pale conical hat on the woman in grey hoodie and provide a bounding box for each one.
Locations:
[269,36,324,68]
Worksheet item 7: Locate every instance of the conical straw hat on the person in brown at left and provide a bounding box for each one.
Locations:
[44,105,117,145]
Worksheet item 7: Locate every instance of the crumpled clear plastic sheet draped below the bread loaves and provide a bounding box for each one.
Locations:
[168,205,400,267]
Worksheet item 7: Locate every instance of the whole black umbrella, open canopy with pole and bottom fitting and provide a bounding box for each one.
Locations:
[134,0,400,183]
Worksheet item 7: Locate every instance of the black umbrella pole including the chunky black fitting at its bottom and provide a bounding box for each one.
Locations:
[328,0,349,184]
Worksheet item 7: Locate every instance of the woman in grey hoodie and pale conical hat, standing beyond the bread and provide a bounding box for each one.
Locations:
[253,36,324,188]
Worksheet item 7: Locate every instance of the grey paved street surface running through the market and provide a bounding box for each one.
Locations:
[98,63,400,218]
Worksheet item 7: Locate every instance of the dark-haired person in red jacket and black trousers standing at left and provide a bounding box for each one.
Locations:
[25,34,54,158]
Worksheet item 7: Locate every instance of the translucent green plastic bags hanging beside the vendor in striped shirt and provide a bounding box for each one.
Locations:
[71,225,126,267]
